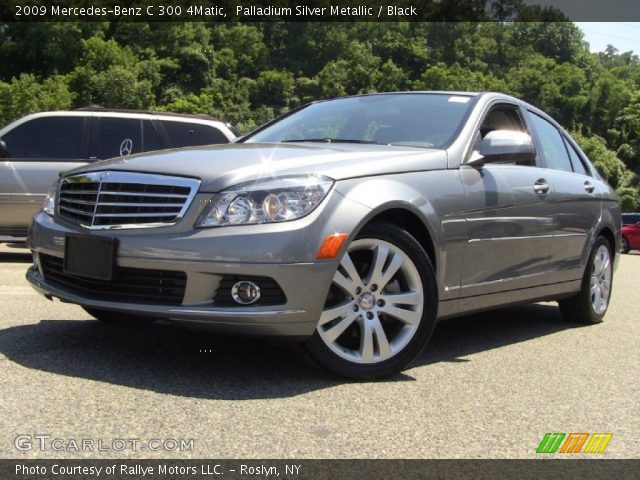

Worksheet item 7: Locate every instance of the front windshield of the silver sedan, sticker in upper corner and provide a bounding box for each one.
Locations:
[245,93,472,148]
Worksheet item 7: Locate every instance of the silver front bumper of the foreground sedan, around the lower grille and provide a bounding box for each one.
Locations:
[27,208,352,337]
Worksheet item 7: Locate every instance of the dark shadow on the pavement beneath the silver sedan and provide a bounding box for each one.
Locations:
[0,304,576,400]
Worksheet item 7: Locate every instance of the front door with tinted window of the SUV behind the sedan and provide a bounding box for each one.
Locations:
[0,116,90,234]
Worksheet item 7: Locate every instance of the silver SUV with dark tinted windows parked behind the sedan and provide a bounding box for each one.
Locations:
[0,109,238,242]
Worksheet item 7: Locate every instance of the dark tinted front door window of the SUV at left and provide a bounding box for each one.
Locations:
[2,117,88,160]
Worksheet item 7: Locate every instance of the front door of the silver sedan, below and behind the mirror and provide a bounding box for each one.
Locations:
[460,104,553,296]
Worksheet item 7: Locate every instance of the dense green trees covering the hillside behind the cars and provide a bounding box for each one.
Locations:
[0,19,640,209]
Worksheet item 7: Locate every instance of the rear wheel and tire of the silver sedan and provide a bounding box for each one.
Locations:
[558,237,613,324]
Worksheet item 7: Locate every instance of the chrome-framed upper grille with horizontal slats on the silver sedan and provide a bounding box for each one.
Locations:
[58,171,200,229]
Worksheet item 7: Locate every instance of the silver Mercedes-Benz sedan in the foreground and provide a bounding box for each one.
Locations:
[27,92,620,378]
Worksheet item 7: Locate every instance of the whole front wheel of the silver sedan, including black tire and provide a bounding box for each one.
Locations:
[305,223,438,379]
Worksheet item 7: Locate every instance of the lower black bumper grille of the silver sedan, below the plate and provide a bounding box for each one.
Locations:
[40,253,187,305]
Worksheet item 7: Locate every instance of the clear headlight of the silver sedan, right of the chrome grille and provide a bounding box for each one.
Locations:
[196,176,333,227]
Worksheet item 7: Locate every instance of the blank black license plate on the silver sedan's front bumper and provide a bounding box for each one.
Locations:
[64,236,117,280]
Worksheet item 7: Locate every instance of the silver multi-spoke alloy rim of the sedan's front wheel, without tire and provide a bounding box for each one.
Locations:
[317,238,424,364]
